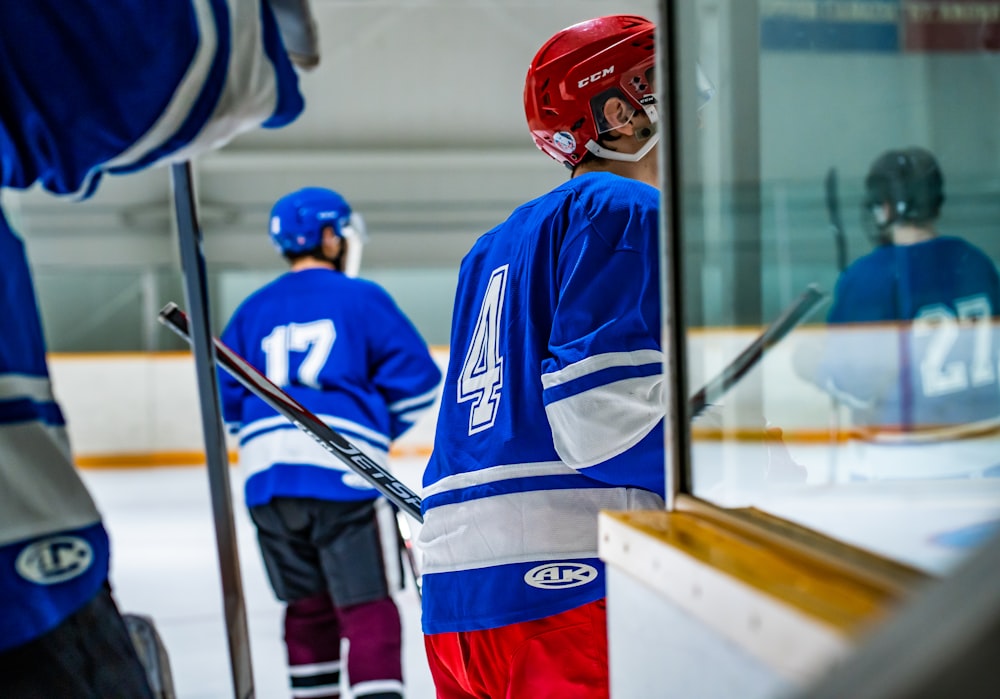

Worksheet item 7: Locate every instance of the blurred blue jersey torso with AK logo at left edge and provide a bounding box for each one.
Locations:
[0,214,108,652]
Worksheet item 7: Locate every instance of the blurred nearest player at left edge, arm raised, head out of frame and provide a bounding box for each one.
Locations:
[0,0,303,699]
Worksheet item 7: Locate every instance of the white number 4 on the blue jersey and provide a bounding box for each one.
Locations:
[458,265,508,435]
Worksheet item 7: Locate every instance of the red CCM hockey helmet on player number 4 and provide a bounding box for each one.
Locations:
[524,15,659,168]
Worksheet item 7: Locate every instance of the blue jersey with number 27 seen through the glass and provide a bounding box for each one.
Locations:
[820,236,1000,432]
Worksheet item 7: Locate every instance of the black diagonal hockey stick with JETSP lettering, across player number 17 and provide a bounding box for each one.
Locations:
[159,303,424,522]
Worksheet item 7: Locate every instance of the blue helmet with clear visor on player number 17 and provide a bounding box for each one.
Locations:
[268,187,366,276]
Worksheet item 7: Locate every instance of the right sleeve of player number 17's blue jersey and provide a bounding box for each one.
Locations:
[370,290,441,439]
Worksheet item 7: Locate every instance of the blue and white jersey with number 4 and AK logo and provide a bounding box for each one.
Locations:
[419,173,665,633]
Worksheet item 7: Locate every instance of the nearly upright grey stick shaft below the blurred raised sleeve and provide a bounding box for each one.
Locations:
[170,161,254,699]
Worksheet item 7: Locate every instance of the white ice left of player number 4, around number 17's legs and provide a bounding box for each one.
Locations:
[83,459,434,699]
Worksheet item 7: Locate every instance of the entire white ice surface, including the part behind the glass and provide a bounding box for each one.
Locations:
[83,445,1000,699]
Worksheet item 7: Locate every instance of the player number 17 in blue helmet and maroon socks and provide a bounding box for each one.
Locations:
[220,187,441,699]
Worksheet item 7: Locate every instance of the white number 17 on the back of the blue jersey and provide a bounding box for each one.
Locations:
[260,319,337,388]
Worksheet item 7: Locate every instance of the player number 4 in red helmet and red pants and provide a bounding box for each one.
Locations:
[418,15,664,699]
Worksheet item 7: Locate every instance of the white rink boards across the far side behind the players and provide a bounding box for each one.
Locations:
[49,328,829,465]
